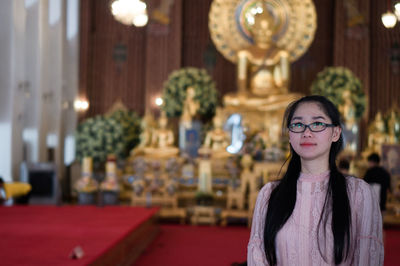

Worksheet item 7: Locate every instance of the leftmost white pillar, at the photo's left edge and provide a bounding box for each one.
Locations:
[0,0,25,181]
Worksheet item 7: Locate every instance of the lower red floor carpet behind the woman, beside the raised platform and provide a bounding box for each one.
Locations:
[135,225,400,266]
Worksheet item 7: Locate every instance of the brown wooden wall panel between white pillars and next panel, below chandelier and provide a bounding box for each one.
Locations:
[79,0,146,116]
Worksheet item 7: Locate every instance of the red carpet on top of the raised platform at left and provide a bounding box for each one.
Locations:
[0,206,157,265]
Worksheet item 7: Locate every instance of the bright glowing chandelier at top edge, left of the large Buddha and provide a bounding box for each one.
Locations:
[111,0,149,27]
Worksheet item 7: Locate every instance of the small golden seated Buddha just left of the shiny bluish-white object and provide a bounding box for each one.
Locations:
[199,109,231,157]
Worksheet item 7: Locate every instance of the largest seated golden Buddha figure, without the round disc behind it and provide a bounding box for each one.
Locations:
[224,8,290,108]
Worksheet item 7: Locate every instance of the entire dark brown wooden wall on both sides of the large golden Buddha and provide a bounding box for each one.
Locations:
[79,0,400,123]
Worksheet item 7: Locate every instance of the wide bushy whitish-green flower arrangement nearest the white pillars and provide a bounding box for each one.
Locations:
[75,111,140,163]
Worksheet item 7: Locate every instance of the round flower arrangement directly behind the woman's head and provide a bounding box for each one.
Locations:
[311,67,366,120]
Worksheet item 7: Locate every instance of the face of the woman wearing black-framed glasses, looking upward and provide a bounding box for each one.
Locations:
[289,102,341,162]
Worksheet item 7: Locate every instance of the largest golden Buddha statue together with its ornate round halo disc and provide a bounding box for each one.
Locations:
[209,0,317,132]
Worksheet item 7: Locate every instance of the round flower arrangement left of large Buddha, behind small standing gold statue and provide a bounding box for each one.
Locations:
[163,67,218,118]
